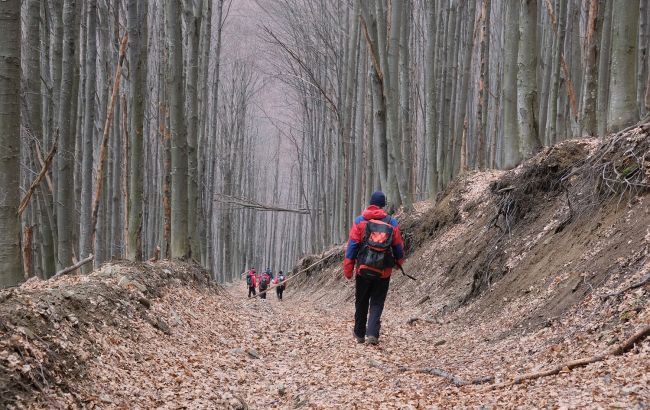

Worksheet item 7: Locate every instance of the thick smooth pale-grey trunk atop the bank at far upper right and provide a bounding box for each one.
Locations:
[607,0,639,132]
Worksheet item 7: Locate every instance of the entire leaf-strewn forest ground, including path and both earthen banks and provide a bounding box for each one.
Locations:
[0,125,650,409]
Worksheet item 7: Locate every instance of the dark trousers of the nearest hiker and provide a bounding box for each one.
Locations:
[354,275,390,337]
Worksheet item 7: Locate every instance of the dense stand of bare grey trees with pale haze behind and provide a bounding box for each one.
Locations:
[0,0,650,287]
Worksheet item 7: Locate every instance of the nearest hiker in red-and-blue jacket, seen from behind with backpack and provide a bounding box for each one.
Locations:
[343,191,404,345]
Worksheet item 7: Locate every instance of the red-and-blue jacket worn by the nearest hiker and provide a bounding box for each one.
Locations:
[343,205,404,279]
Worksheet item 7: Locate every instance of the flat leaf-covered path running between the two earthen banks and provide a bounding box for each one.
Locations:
[49,287,650,409]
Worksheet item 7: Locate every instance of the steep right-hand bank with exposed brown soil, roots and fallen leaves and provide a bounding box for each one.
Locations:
[288,124,650,406]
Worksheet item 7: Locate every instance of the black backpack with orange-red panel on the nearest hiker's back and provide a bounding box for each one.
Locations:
[357,216,395,278]
